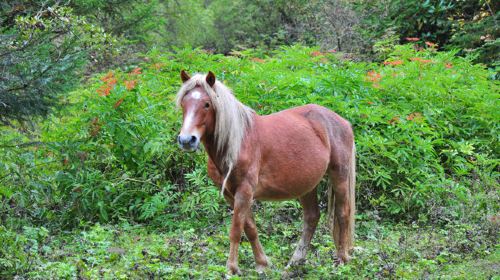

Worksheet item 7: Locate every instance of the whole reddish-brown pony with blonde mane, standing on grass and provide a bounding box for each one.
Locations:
[177,71,355,274]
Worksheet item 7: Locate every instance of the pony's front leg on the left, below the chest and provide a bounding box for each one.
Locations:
[227,183,253,274]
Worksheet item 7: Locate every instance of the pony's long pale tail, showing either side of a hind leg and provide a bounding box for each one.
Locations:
[328,144,356,252]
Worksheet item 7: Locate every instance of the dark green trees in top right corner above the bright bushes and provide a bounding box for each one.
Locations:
[355,0,500,65]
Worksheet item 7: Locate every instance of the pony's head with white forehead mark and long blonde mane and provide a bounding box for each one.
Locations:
[177,70,254,169]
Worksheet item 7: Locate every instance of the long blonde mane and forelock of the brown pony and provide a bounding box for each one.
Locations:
[176,74,254,172]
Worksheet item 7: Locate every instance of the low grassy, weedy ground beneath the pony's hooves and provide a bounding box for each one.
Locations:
[4,205,500,279]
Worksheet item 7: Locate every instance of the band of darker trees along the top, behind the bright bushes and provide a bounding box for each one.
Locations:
[0,0,500,123]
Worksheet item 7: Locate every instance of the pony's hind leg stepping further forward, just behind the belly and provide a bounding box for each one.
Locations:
[287,188,320,267]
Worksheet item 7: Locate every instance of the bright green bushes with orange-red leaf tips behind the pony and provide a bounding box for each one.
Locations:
[0,46,498,227]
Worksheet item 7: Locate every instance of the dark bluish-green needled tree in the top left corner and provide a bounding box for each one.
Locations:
[0,4,114,125]
